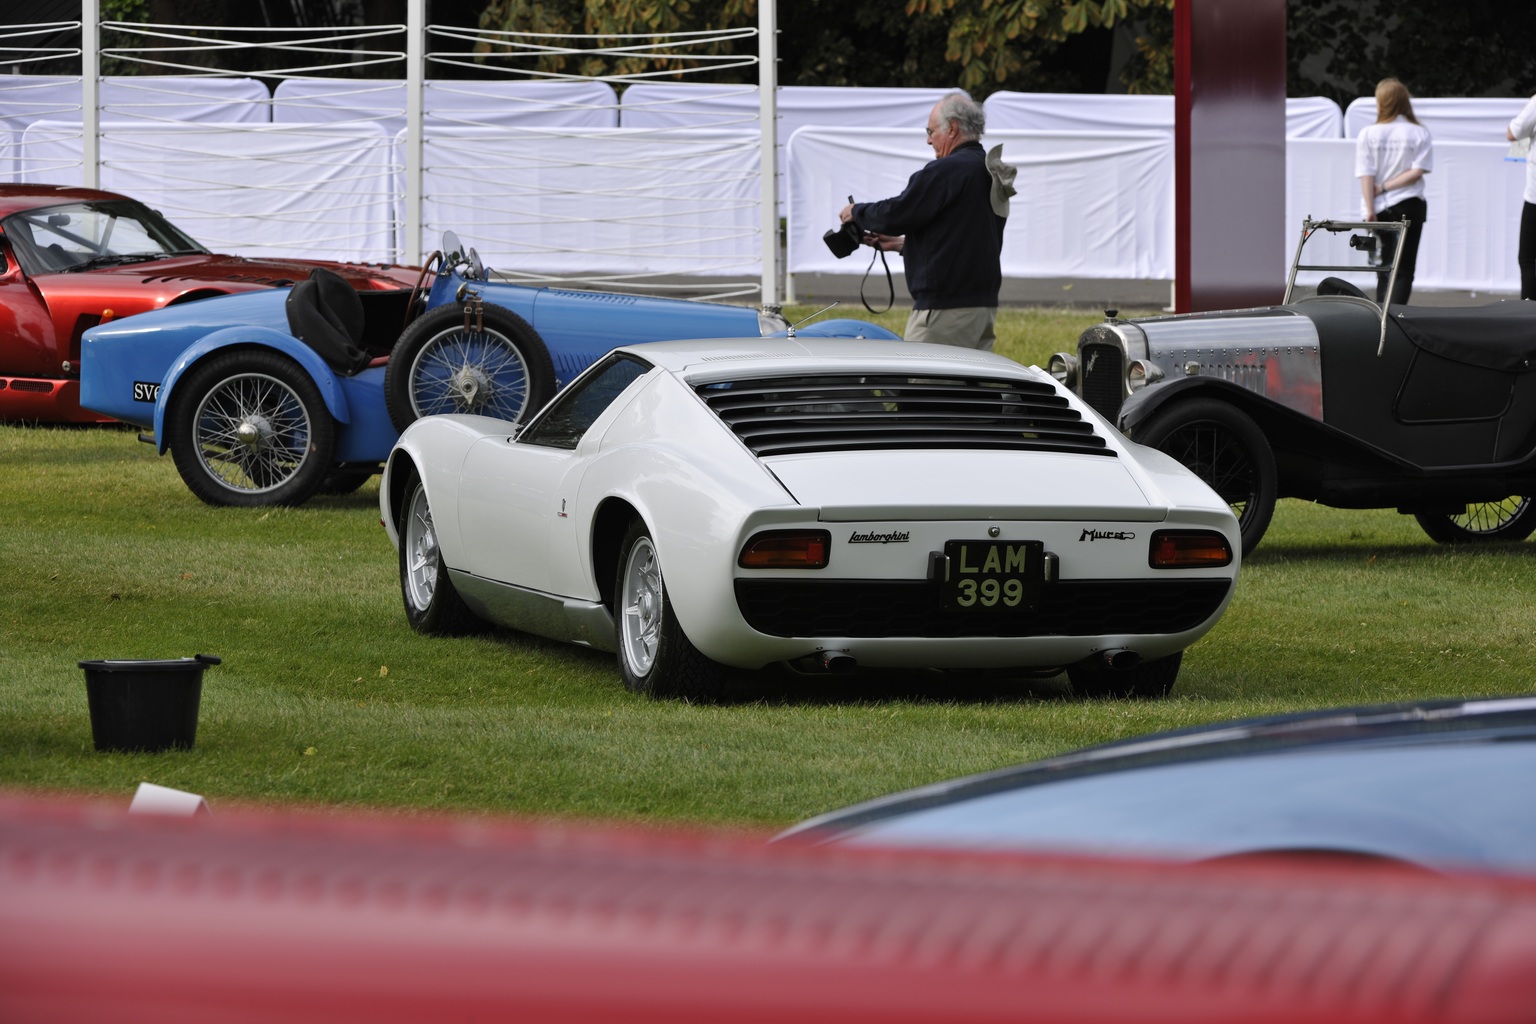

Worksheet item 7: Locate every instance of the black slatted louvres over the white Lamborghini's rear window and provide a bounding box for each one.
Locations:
[697,375,1115,456]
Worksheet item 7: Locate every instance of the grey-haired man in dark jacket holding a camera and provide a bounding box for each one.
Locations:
[840,92,1014,348]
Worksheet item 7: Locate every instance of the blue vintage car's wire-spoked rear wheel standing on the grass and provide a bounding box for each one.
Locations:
[169,348,336,507]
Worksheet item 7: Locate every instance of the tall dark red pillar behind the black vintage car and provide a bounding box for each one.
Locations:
[1174,0,1290,312]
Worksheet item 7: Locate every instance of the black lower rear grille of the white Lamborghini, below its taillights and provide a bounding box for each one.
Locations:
[736,579,1232,637]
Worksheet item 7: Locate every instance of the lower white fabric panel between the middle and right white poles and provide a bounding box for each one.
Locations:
[414,127,762,276]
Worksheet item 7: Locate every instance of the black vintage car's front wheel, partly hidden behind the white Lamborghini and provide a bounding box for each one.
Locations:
[1134,398,1279,556]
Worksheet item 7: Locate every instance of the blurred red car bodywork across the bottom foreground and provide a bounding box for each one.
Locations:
[0,797,1536,1024]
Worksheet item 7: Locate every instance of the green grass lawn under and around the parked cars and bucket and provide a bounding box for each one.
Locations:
[0,312,1536,826]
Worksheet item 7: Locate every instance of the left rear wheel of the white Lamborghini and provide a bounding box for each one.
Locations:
[613,519,725,702]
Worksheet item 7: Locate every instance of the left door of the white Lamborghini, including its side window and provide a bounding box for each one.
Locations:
[459,353,651,597]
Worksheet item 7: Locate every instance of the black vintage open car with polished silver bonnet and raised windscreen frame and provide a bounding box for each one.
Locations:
[1051,220,1536,553]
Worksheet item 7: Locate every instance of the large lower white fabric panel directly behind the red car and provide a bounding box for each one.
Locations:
[23,121,396,261]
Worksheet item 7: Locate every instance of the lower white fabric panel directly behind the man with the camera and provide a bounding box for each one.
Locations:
[788,127,1174,279]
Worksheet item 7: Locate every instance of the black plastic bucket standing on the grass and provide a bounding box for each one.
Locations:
[80,654,220,752]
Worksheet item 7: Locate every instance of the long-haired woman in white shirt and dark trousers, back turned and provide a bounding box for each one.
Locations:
[1355,78,1435,304]
